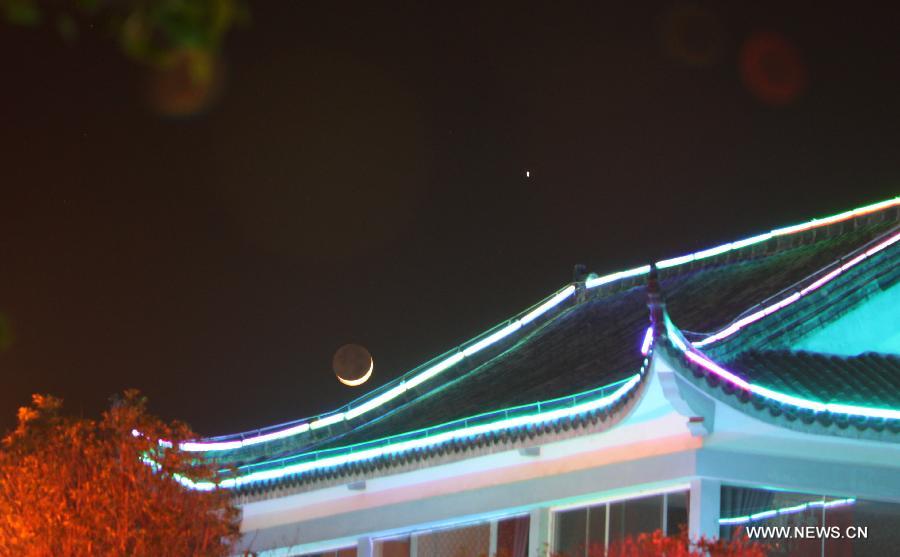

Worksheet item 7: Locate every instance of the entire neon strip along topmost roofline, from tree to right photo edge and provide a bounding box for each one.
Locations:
[180,197,900,451]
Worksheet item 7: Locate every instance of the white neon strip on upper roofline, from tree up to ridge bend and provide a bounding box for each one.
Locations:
[180,285,575,451]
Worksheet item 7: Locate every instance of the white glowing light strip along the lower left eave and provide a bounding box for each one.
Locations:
[186,374,641,490]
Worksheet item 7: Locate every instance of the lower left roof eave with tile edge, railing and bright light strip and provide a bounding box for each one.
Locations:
[190,366,646,496]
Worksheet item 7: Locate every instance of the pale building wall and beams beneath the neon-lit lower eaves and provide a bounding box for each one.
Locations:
[237,350,900,555]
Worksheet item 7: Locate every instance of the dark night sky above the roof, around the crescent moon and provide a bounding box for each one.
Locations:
[0,1,900,435]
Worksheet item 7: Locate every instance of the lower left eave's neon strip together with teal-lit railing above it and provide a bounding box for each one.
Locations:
[179,368,643,490]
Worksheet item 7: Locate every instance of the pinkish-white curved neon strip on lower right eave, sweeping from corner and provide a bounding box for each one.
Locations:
[666,321,900,420]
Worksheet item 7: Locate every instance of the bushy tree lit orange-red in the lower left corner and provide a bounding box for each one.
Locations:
[0,391,240,557]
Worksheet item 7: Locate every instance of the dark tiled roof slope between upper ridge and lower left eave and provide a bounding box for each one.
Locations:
[312,286,647,446]
